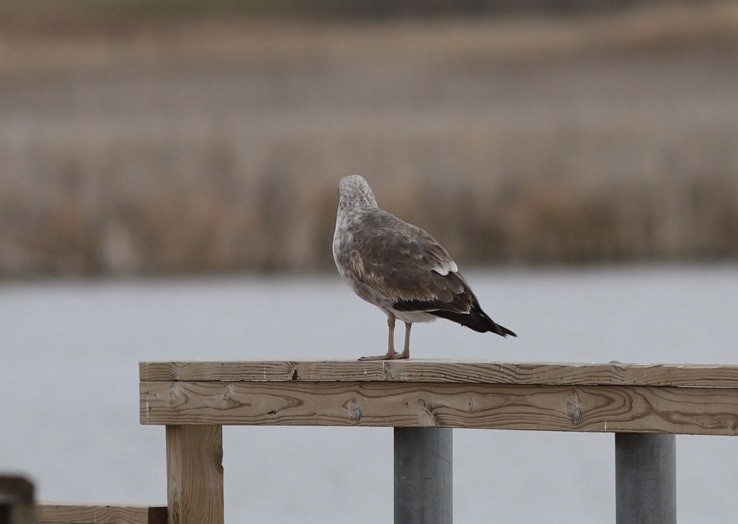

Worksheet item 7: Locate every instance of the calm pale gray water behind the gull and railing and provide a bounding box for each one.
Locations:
[0,266,738,524]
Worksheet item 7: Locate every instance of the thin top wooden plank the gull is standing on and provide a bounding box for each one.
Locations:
[139,360,738,388]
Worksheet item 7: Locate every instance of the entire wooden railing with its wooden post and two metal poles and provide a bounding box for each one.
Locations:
[140,360,738,524]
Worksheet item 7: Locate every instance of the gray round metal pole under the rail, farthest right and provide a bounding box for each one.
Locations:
[615,433,676,524]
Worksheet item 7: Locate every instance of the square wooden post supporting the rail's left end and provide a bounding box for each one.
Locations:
[166,426,224,524]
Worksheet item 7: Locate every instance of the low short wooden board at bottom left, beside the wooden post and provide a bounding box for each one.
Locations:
[38,504,167,524]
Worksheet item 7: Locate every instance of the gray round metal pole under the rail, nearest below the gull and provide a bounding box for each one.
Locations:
[395,428,453,524]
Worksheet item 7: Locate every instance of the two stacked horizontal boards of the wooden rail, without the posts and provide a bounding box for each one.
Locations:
[140,360,738,435]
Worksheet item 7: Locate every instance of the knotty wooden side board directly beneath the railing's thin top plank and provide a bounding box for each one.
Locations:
[140,382,738,435]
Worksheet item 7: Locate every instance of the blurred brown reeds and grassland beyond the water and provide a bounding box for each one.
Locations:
[0,0,738,278]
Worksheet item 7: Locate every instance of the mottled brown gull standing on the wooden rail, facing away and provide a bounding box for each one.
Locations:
[333,175,517,360]
